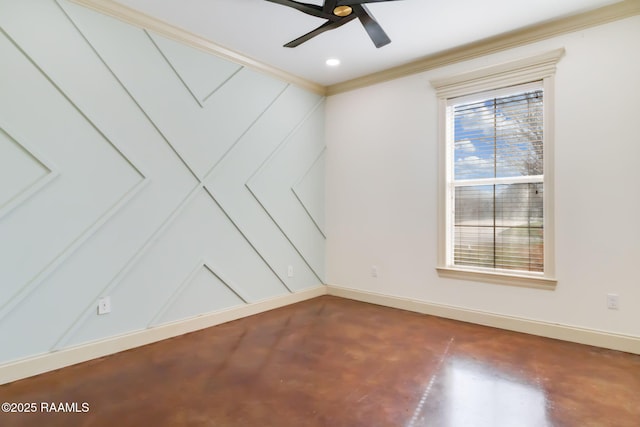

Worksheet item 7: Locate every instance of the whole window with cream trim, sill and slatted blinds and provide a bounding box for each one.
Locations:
[432,50,564,288]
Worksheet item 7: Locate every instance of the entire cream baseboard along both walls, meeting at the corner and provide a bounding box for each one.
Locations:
[0,285,640,384]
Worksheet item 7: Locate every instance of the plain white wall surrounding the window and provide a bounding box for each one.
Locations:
[326,16,640,337]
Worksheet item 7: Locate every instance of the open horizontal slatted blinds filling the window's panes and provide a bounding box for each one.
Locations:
[449,86,544,272]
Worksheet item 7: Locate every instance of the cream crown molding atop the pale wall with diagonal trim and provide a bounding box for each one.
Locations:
[71,0,326,95]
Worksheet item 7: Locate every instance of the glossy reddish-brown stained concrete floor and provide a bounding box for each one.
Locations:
[0,296,640,427]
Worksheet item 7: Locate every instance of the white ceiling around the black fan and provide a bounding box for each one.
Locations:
[112,0,620,86]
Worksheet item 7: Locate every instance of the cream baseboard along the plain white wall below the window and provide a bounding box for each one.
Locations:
[327,285,640,354]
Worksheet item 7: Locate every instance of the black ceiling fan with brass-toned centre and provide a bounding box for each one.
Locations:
[267,0,396,48]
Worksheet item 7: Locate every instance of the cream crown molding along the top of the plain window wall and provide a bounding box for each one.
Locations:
[327,0,640,96]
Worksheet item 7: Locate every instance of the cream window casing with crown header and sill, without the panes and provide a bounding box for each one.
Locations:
[431,48,565,289]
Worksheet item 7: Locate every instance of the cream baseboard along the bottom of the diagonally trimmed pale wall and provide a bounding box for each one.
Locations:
[0,285,327,384]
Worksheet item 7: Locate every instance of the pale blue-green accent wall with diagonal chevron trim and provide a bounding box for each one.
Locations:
[0,0,324,365]
